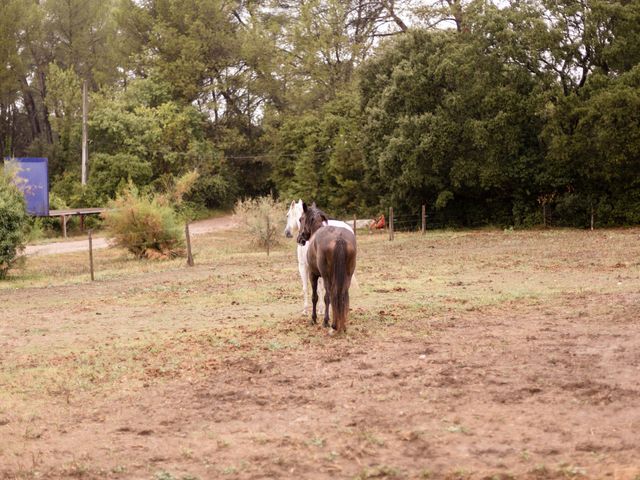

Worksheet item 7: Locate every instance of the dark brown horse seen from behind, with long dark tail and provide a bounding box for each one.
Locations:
[298,203,356,332]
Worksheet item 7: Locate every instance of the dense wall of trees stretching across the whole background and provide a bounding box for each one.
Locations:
[0,0,640,226]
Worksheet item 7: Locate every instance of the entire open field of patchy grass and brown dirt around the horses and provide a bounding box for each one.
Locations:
[0,229,640,480]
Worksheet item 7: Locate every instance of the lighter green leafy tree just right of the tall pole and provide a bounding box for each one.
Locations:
[82,79,234,206]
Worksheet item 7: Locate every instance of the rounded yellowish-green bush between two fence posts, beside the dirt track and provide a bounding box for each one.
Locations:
[103,184,185,259]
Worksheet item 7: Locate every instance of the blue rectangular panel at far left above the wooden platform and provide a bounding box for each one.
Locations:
[5,158,49,217]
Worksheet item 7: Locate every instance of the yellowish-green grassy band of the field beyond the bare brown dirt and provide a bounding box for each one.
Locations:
[0,230,640,401]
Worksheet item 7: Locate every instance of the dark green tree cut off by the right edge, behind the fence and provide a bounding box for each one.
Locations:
[543,66,640,226]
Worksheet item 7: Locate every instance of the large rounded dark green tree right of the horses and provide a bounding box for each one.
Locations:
[361,27,540,224]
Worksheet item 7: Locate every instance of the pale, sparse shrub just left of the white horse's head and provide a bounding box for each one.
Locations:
[235,196,286,255]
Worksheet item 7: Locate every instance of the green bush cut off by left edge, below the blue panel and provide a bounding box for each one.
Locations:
[0,171,29,279]
